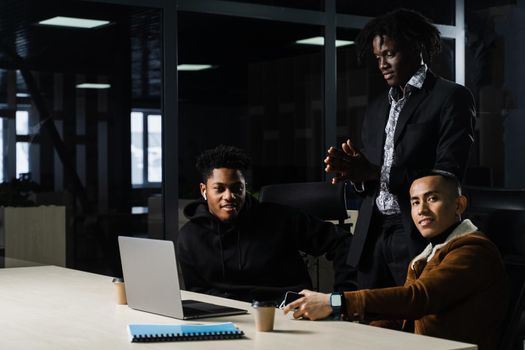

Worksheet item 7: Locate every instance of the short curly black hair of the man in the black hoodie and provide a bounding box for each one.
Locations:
[196,145,252,182]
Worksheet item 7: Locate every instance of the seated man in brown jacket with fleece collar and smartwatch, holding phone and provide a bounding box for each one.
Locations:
[284,170,508,350]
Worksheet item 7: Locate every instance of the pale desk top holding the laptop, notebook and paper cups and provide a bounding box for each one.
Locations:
[0,266,476,350]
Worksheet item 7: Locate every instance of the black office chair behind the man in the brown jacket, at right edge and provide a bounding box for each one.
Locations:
[485,209,525,350]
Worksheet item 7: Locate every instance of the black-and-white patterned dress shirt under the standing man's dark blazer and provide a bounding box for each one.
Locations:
[376,65,428,215]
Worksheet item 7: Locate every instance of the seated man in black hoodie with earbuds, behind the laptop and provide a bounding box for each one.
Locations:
[176,145,355,301]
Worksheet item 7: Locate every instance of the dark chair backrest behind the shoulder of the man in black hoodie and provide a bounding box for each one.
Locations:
[259,182,348,221]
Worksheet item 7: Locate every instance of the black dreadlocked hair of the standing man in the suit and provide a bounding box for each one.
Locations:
[356,8,441,63]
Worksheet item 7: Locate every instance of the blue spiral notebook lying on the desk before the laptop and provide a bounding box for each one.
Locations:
[128,322,244,343]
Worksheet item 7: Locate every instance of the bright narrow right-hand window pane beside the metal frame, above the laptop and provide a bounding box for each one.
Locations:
[148,114,162,182]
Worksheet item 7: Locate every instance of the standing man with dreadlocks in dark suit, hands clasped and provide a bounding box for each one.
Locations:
[325,9,475,288]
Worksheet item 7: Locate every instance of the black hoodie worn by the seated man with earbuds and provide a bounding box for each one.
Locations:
[176,195,353,301]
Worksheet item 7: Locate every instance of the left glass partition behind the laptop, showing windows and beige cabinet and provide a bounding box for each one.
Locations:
[0,0,162,275]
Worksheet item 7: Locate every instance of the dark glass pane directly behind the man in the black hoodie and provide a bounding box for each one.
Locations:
[178,11,324,205]
